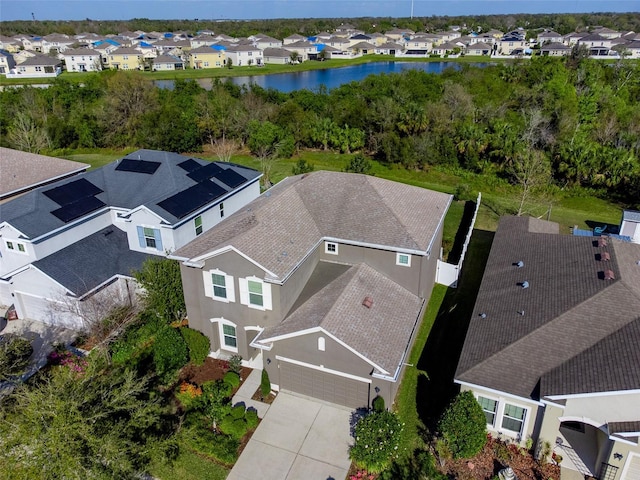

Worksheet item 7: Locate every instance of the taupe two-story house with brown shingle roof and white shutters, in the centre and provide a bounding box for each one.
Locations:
[172,171,451,407]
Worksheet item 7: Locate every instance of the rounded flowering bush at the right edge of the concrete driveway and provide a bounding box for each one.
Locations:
[349,410,402,473]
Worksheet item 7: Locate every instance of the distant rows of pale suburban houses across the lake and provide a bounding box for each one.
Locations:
[0,24,640,78]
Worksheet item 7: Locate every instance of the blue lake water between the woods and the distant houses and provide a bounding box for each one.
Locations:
[155,62,488,92]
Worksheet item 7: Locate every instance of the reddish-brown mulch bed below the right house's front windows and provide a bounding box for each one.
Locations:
[441,437,560,480]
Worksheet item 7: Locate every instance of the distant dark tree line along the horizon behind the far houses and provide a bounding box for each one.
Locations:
[0,12,640,38]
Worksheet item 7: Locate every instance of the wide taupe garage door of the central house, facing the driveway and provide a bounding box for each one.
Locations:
[278,360,370,408]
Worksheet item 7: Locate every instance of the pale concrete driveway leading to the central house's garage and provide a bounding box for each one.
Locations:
[227,392,353,480]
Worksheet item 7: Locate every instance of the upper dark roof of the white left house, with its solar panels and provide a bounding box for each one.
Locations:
[0,150,260,238]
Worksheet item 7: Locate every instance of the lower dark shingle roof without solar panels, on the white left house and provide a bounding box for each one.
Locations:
[32,225,155,297]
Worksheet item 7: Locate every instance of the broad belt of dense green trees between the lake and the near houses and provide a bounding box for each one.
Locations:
[0,56,640,204]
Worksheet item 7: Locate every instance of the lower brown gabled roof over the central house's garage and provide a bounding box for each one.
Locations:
[255,262,424,376]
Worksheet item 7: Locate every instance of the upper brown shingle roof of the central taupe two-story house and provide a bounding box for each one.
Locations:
[175,171,451,279]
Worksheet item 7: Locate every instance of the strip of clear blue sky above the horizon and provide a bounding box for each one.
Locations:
[0,0,640,21]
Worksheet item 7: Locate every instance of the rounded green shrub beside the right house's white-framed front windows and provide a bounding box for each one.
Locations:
[438,390,487,458]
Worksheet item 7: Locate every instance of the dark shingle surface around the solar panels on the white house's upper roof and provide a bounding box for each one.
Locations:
[0,150,260,239]
